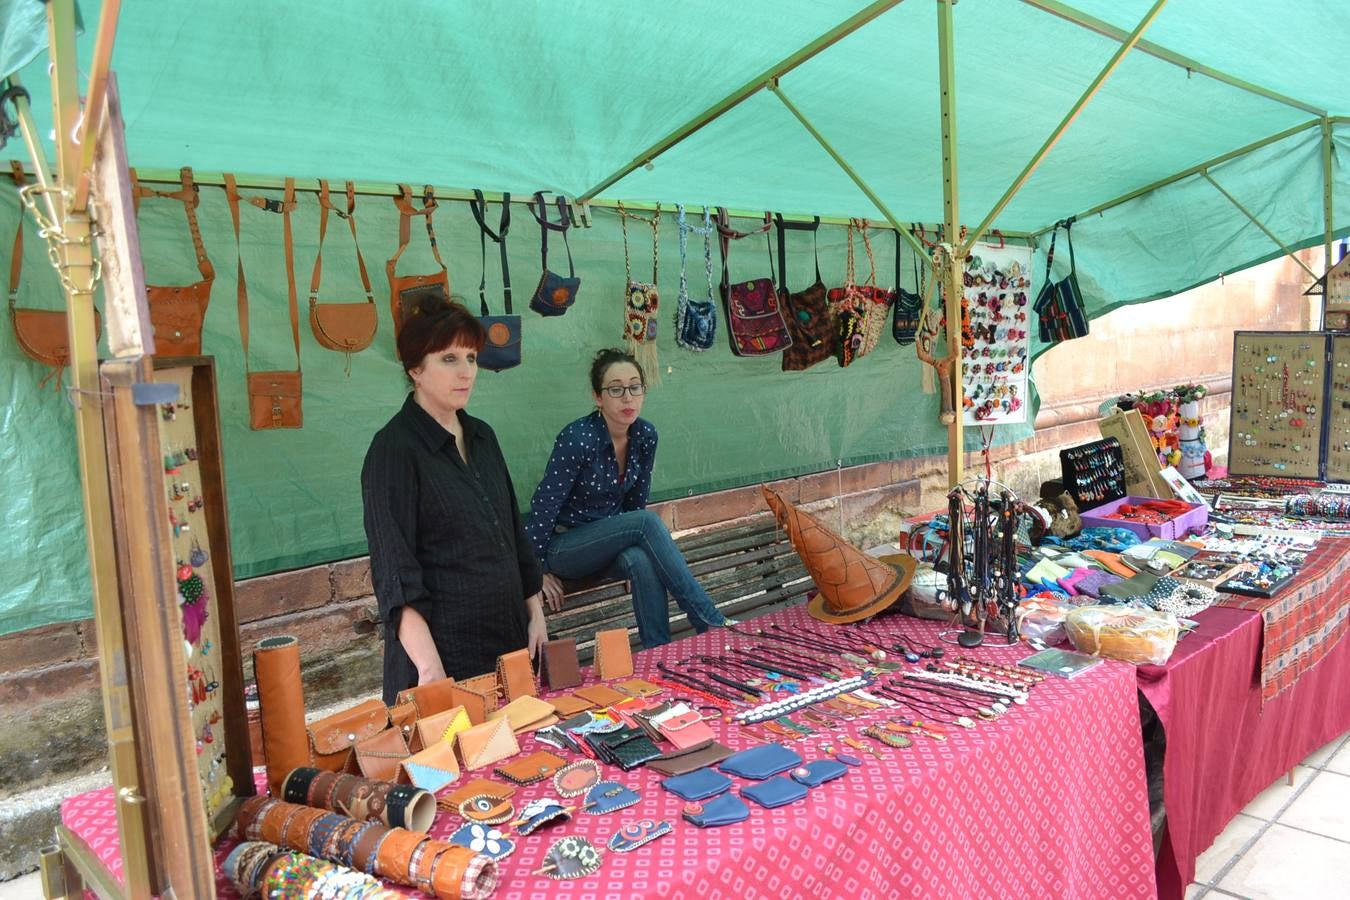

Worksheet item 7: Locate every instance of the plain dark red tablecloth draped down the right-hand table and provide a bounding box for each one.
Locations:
[1138,600,1350,899]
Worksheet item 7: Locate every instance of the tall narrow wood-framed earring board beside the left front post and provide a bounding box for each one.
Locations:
[155,358,254,837]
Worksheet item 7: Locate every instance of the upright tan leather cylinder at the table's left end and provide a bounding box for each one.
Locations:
[254,634,311,793]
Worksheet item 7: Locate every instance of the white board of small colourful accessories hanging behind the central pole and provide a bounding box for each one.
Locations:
[961,244,1031,425]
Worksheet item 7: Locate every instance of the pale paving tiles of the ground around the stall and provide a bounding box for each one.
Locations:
[0,733,1350,900]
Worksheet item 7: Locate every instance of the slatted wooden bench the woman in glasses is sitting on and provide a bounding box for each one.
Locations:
[545,515,814,663]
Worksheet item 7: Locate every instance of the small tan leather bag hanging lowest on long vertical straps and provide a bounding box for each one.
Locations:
[225,174,304,430]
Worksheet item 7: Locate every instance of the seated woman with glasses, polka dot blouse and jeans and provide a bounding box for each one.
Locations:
[525,348,732,648]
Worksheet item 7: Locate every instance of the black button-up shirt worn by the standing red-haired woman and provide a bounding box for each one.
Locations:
[360,395,541,703]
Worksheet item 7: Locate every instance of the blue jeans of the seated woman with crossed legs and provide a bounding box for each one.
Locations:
[548,510,726,648]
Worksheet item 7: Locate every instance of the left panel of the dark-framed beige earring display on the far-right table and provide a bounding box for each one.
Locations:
[1229,332,1328,478]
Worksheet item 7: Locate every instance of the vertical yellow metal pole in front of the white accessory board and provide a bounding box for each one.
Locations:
[937,0,965,487]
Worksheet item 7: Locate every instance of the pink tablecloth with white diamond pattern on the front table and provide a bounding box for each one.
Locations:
[62,607,1156,900]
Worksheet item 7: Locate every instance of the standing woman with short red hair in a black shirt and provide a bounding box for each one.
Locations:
[360,298,548,703]
